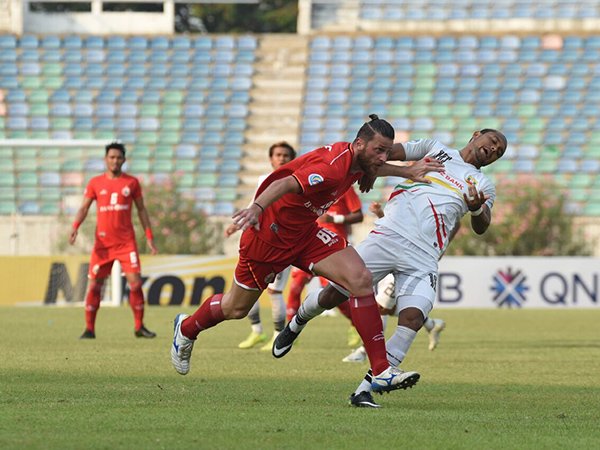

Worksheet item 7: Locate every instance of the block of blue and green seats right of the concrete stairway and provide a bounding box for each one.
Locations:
[300,33,600,215]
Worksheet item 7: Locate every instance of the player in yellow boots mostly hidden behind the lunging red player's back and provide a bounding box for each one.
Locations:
[225,141,296,351]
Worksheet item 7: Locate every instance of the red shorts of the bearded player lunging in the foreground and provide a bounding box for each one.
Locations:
[235,227,348,290]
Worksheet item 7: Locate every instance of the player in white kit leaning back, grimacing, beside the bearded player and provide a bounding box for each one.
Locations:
[276,129,507,408]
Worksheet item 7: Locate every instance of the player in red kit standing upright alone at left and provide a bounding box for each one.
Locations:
[69,142,157,339]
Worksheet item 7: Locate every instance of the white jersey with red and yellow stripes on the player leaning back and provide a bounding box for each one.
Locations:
[375,139,496,258]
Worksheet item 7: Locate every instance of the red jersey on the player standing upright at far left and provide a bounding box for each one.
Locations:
[83,173,142,247]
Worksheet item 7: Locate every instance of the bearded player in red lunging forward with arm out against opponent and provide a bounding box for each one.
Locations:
[171,115,438,398]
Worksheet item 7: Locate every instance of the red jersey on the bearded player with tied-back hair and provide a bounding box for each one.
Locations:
[249,142,362,249]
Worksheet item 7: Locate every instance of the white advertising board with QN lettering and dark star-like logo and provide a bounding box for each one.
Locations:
[435,256,600,309]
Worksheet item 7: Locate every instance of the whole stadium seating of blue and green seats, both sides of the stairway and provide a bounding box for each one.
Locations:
[0,9,600,220]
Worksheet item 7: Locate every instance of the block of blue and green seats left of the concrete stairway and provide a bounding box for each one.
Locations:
[0,34,257,214]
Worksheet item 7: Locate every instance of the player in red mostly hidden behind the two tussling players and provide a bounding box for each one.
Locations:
[286,187,364,322]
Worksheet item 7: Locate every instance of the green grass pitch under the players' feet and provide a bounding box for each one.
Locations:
[0,307,600,450]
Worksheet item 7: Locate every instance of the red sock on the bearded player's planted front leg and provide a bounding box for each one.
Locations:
[349,294,390,375]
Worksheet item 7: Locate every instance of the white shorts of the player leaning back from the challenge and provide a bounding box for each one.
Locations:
[336,227,438,316]
